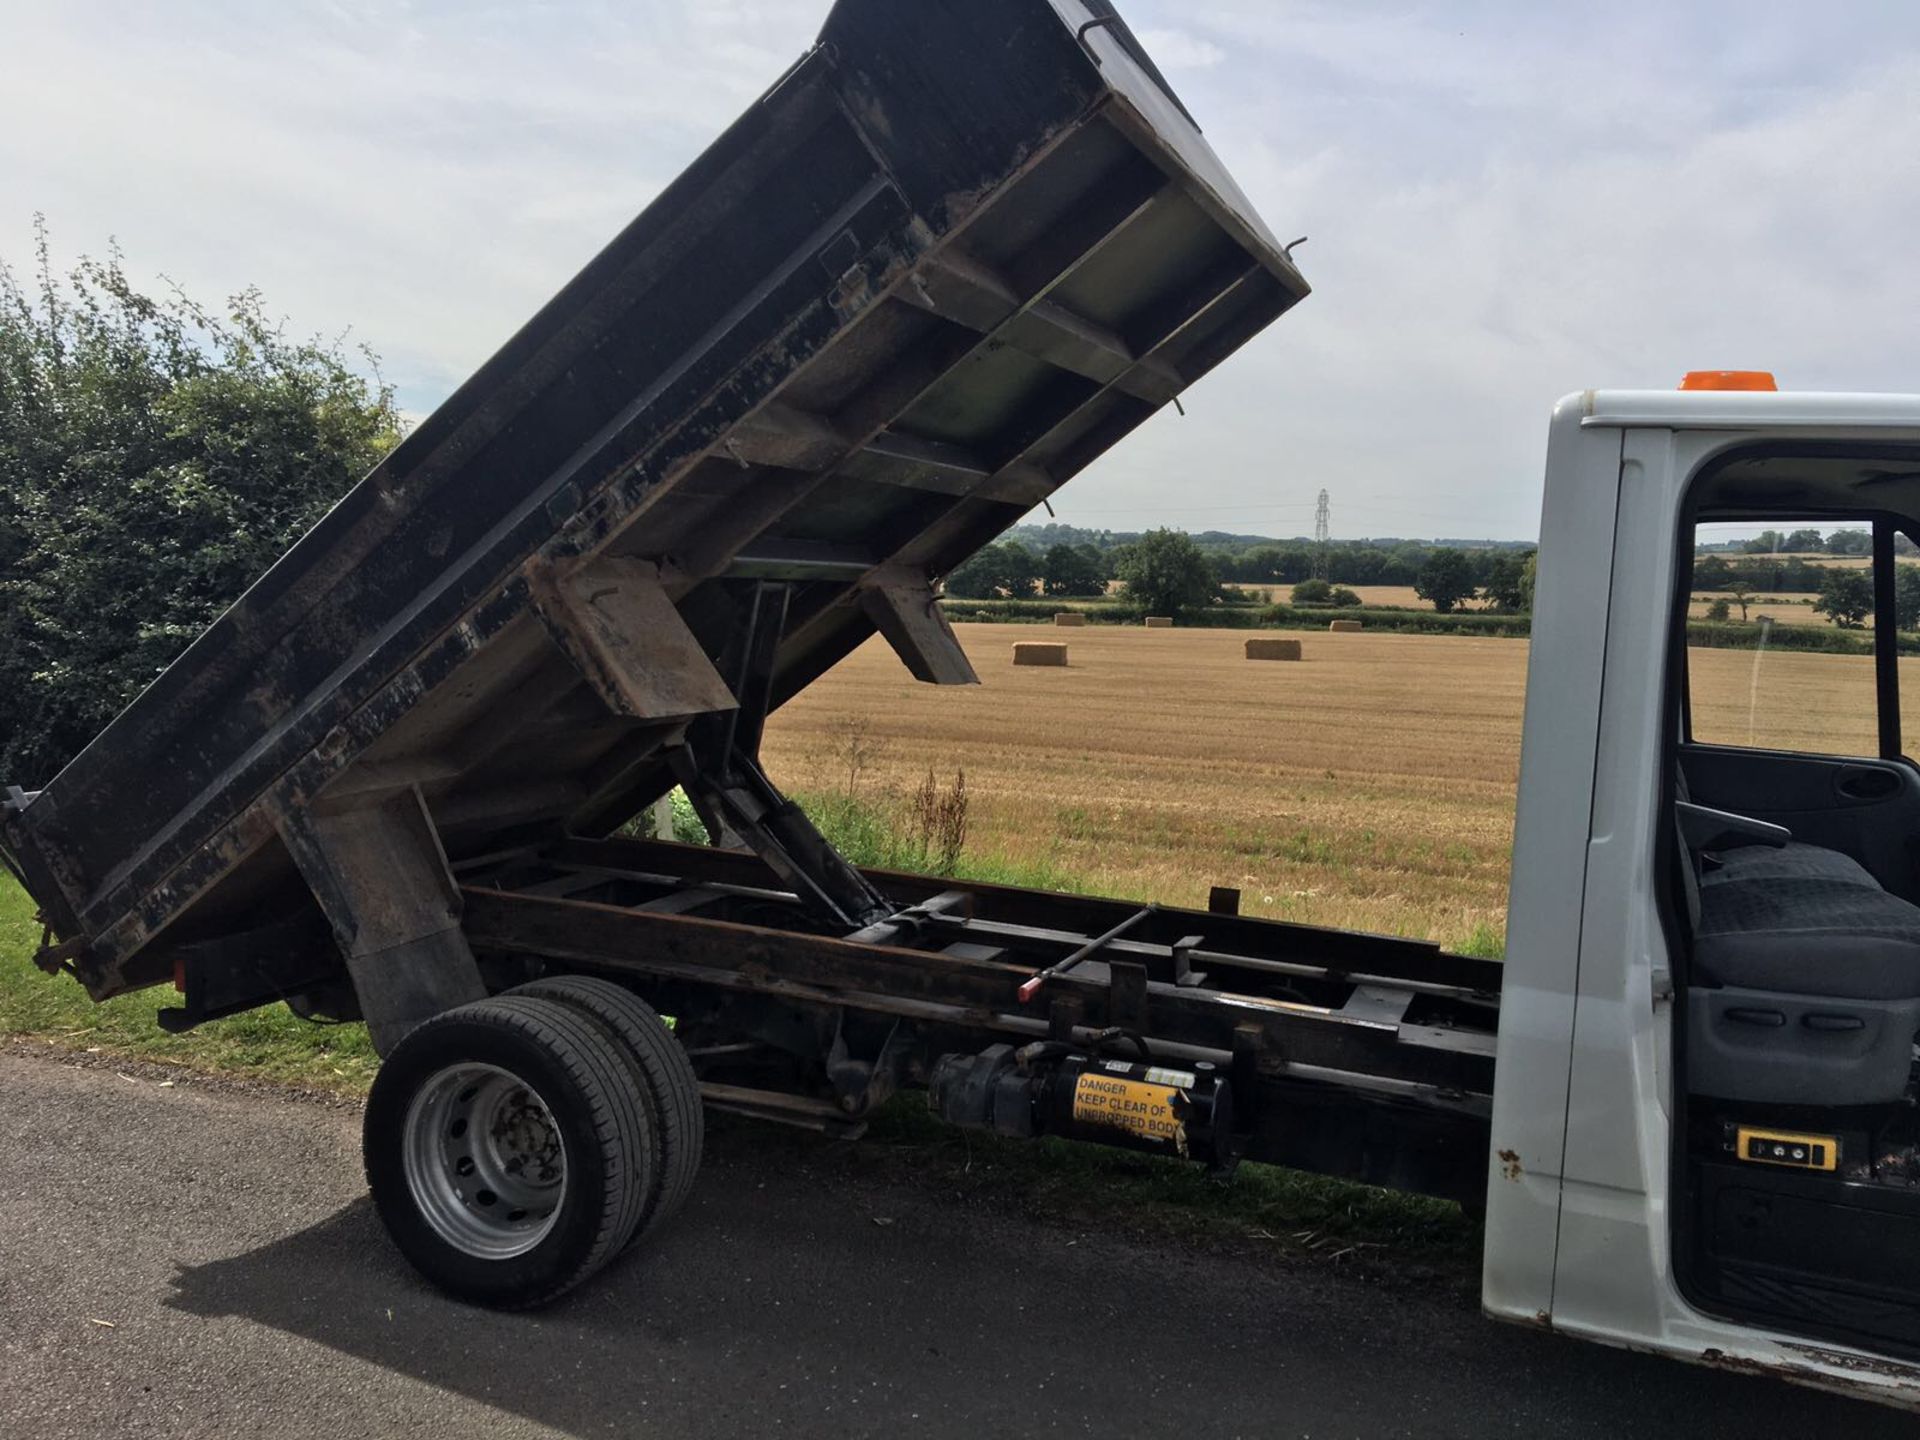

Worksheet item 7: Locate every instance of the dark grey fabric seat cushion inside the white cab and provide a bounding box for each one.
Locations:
[1693,845,1920,1000]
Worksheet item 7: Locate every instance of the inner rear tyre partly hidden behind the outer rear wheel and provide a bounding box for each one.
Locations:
[509,975,707,1242]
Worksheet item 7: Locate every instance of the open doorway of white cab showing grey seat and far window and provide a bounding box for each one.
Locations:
[1670,514,1920,1357]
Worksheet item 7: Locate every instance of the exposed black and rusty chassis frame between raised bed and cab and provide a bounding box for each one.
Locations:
[455,821,1500,1208]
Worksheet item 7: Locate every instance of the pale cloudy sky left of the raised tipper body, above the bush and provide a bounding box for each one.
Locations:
[0,0,818,407]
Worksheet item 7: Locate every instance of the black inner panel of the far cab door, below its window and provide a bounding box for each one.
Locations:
[1680,745,1920,900]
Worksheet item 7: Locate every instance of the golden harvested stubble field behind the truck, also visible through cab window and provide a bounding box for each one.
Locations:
[764,624,1889,948]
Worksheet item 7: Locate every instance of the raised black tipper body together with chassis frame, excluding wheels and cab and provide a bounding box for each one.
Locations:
[0,0,1498,1221]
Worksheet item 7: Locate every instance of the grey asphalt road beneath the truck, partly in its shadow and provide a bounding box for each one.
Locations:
[0,1048,1914,1440]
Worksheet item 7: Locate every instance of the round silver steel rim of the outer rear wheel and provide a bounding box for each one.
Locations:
[401,1064,566,1260]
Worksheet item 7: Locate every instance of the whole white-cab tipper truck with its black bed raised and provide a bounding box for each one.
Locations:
[11,0,1920,1404]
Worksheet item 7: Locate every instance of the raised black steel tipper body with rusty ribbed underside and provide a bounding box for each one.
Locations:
[6,0,1306,995]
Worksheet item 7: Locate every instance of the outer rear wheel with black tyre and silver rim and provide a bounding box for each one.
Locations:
[363,996,657,1309]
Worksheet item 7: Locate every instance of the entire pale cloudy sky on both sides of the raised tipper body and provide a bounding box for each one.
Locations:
[0,0,1920,540]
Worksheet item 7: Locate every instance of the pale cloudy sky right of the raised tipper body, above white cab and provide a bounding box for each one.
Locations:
[1056,6,1920,536]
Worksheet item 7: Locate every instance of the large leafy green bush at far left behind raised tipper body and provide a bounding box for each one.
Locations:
[0,227,401,785]
